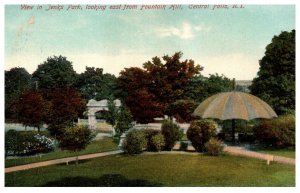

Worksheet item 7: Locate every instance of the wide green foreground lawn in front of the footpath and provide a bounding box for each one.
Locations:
[5,154,295,187]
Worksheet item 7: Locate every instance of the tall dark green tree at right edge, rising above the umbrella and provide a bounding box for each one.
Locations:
[250,30,295,114]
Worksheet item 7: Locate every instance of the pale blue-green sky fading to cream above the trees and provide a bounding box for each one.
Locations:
[4,4,295,80]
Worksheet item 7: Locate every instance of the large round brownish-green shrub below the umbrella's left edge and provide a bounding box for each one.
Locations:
[187,120,216,152]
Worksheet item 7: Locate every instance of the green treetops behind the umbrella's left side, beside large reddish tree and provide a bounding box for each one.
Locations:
[184,74,232,102]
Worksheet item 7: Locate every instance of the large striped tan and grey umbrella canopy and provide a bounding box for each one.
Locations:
[192,91,277,120]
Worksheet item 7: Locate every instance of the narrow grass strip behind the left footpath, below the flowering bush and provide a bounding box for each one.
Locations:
[5,138,117,167]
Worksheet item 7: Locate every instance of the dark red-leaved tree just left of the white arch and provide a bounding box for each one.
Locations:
[48,87,85,138]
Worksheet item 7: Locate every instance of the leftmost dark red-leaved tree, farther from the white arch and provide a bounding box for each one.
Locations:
[17,89,50,131]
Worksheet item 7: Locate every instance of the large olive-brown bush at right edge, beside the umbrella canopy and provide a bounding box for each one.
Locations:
[253,115,296,147]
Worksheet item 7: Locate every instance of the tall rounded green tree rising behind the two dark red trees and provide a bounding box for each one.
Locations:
[32,56,77,90]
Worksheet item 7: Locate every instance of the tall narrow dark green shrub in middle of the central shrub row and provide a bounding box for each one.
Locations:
[161,120,182,151]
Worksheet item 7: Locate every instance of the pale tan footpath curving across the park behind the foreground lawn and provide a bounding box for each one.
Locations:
[5,146,295,173]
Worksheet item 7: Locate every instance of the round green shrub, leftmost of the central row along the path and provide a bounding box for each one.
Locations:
[123,130,147,155]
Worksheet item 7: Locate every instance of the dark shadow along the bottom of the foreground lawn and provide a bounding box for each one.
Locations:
[43,174,162,187]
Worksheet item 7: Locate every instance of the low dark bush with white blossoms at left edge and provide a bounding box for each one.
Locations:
[5,130,55,155]
